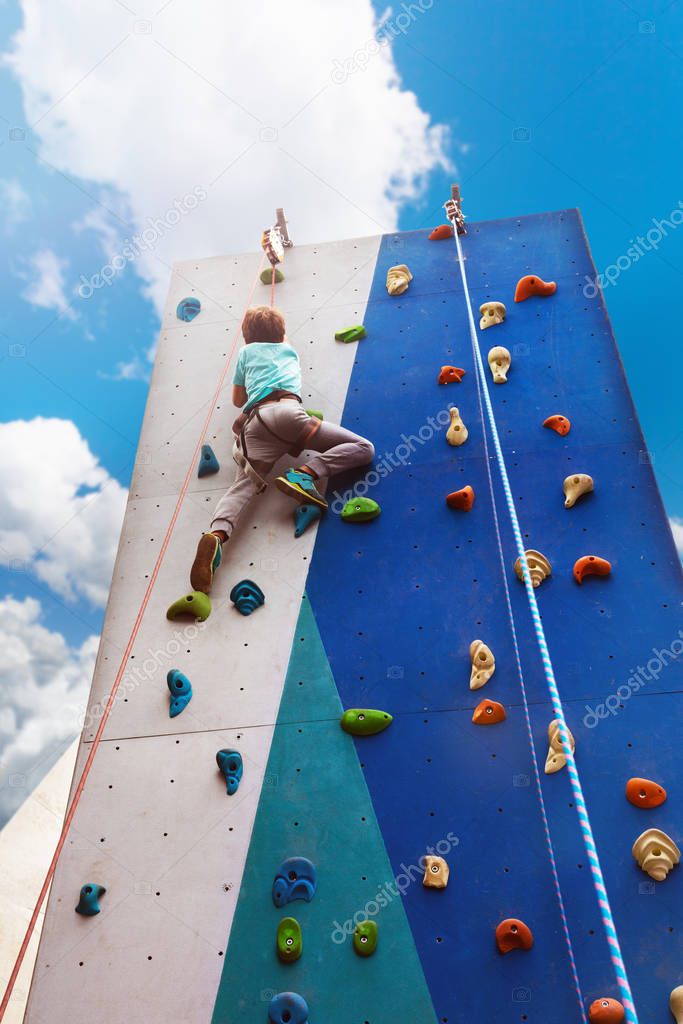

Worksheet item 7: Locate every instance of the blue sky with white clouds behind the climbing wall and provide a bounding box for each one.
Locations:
[0,0,683,815]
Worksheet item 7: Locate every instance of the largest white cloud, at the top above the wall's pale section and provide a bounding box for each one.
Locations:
[6,0,454,308]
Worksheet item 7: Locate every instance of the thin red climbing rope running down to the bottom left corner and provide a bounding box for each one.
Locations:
[0,251,266,1021]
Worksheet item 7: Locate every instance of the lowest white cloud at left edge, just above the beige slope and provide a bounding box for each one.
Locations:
[0,597,98,818]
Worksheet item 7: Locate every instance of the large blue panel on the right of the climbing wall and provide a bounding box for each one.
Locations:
[308,211,683,1024]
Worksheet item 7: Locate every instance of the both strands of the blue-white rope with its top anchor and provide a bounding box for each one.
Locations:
[444,185,638,1024]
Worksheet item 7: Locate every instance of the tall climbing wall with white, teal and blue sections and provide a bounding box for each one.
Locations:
[26,211,683,1024]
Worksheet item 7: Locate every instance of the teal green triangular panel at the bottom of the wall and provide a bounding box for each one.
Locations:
[213,597,435,1024]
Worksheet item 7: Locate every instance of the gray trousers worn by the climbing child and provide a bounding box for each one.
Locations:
[211,398,375,537]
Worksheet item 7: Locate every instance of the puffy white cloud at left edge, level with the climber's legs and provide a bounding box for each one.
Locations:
[0,418,126,606]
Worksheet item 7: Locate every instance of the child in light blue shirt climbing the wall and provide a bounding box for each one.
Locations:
[189,306,375,594]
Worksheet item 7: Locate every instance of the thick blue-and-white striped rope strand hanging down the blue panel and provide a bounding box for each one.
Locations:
[449,214,638,1024]
